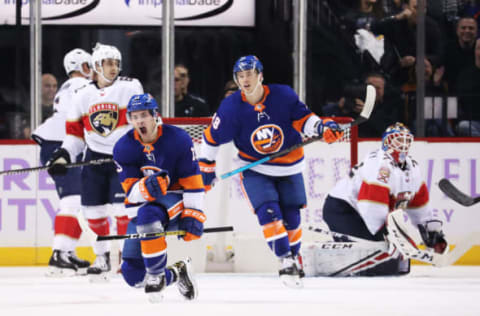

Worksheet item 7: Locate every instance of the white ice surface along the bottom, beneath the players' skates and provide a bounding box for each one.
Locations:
[0,266,480,316]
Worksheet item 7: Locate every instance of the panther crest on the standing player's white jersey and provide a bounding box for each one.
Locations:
[88,103,119,136]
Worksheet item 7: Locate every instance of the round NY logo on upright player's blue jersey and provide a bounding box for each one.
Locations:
[250,124,284,155]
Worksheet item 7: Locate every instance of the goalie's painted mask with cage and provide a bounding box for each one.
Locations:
[382,122,413,163]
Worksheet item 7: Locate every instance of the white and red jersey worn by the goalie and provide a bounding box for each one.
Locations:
[329,149,432,235]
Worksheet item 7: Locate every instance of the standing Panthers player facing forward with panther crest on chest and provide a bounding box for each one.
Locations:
[47,43,143,280]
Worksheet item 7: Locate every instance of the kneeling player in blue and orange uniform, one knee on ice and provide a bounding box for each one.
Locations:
[113,94,206,302]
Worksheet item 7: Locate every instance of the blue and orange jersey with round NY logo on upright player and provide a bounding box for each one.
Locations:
[200,84,320,176]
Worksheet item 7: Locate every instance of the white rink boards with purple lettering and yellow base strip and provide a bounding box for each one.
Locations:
[0,141,480,272]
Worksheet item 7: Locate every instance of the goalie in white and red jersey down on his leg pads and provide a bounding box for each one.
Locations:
[302,123,448,276]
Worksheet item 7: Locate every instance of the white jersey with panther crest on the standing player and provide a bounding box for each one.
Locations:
[62,77,143,157]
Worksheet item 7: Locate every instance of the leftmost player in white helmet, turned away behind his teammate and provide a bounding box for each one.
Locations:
[32,48,92,276]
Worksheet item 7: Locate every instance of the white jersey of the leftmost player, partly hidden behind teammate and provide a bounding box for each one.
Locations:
[33,77,89,142]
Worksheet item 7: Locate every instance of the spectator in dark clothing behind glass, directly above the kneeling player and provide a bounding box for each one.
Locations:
[174,64,210,117]
